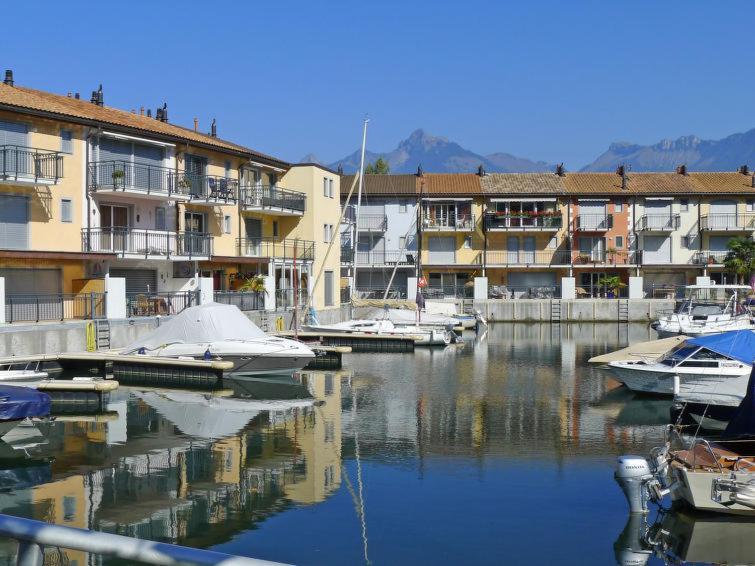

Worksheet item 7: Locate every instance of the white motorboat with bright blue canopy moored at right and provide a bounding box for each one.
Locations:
[607,330,755,398]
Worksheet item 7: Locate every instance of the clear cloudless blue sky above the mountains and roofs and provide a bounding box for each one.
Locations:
[0,0,755,170]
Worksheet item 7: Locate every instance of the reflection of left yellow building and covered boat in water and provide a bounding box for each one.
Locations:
[0,372,348,564]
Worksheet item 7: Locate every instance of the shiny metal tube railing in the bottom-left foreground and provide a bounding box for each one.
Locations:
[0,515,278,566]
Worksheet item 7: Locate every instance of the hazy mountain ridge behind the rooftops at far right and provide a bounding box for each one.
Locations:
[582,129,755,171]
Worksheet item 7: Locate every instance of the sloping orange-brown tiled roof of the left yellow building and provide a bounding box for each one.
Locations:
[0,84,289,167]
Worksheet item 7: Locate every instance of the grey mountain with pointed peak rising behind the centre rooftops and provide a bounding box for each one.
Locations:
[329,129,554,173]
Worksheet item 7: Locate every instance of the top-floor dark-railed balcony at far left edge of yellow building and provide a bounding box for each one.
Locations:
[0,145,63,185]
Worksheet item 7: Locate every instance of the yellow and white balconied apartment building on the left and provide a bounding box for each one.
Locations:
[0,72,340,320]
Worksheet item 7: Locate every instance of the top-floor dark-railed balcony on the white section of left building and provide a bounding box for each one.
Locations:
[87,161,191,200]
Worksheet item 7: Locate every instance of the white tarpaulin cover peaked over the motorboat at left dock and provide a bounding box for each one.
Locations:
[124,303,267,353]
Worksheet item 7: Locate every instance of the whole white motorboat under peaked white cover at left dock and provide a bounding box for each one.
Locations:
[122,303,315,377]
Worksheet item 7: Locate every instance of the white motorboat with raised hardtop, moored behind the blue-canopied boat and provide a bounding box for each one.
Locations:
[652,285,754,336]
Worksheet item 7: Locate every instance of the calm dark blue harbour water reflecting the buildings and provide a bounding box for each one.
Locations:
[0,324,740,565]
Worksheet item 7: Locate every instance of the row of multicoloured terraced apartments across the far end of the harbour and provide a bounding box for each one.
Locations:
[342,166,755,298]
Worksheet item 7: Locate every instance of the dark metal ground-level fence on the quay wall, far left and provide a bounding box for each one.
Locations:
[5,293,107,322]
